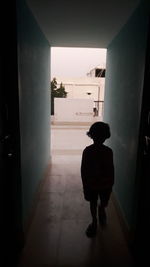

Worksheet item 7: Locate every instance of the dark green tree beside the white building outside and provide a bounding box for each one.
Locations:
[50,78,67,115]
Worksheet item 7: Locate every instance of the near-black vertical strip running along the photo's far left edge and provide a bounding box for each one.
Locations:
[0,2,24,266]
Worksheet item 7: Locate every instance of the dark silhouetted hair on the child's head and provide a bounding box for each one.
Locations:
[87,121,111,139]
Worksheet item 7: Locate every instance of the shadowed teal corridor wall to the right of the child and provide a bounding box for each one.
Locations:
[104,2,148,229]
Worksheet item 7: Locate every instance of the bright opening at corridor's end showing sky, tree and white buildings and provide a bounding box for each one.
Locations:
[51,47,107,154]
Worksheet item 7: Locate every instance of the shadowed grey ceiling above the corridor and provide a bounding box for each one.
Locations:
[26,0,140,48]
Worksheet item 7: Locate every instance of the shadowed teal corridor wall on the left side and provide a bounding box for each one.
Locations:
[18,1,50,226]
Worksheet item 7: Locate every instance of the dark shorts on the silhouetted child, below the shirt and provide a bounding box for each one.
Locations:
[84,188,112,206]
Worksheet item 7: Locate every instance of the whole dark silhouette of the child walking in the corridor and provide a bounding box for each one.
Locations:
[81,122,114,237]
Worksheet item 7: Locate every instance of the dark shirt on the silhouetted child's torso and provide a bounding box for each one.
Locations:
[81,144,114,190]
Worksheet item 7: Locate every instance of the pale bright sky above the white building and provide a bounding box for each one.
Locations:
[51,47,107,78]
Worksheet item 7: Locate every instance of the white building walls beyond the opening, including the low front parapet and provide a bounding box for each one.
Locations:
[53,77,105,123]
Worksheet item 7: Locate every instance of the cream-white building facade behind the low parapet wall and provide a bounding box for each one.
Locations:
[53,67,105,117]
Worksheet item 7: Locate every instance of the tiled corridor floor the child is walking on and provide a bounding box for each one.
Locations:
[19,150,133,267]
